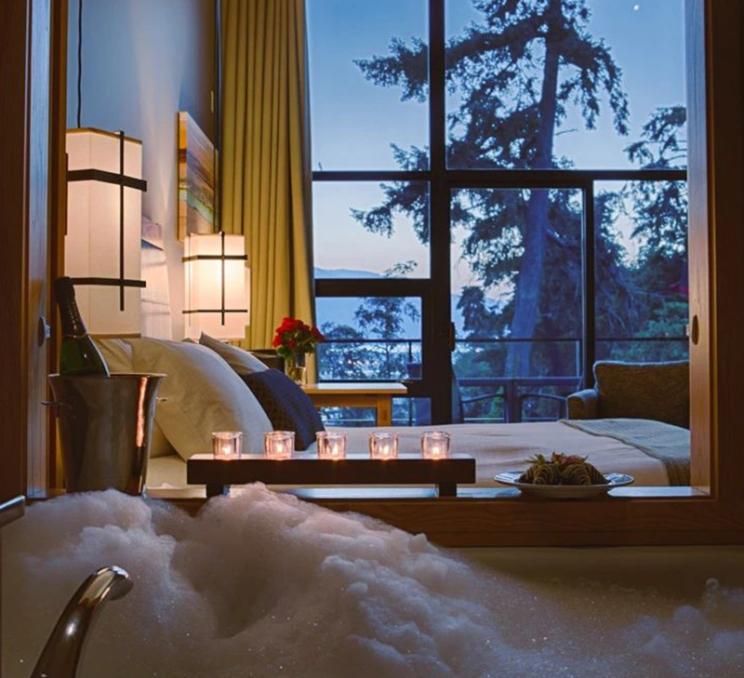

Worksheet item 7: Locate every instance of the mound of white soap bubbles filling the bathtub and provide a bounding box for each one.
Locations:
[2,485,744,678]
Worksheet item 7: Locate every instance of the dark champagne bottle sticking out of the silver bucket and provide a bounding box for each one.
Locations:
[54,276,109,377]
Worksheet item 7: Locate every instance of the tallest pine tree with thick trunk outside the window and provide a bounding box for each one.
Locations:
[354,0,628,376]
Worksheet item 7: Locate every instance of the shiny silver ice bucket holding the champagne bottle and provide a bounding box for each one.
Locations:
[49,374,165,494]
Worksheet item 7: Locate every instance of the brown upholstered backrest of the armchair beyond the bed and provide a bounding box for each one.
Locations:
[594,360,690,428]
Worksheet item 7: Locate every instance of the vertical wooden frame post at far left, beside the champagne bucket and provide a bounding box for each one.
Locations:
[0,0,67,501]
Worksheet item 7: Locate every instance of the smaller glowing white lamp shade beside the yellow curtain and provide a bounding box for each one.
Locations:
[184,233,250,339]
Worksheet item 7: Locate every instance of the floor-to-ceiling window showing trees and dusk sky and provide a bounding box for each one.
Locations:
[308,0,687,423]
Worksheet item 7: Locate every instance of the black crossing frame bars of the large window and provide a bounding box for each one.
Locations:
[312,0,687,424]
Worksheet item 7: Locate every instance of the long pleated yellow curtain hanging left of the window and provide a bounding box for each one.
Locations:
[220,0,314,348]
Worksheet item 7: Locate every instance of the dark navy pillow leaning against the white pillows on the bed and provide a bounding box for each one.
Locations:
[243,368,325,451]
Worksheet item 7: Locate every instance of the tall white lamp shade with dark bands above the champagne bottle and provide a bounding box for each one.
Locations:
[65,129,142,335]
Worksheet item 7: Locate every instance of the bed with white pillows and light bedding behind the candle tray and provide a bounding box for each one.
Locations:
[94,337,690,489]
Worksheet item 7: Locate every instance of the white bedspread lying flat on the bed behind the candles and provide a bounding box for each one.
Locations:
[147,421,669,488]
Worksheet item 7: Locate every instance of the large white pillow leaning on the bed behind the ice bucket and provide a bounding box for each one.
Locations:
[133,339,271,459]
